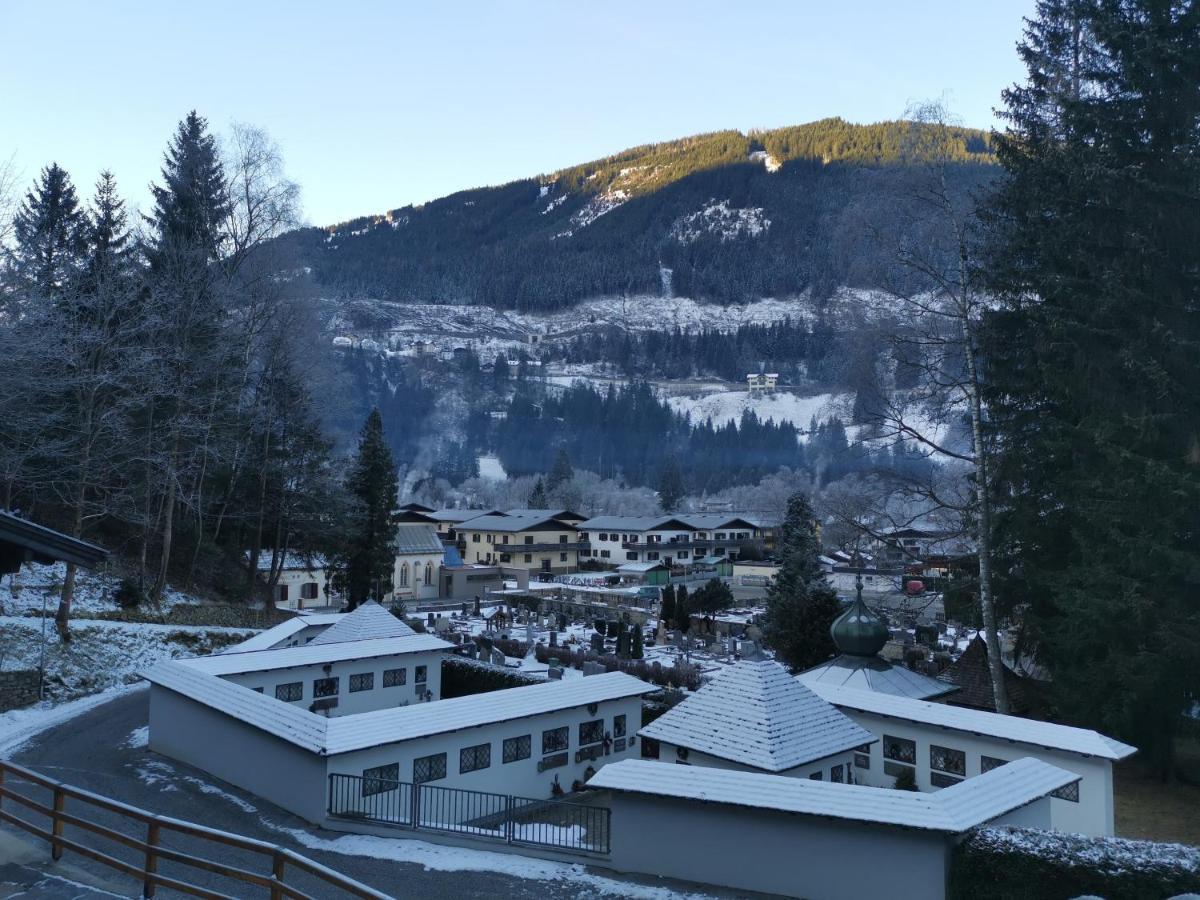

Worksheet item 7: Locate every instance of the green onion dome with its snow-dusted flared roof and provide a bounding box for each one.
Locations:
[797,589,956,700]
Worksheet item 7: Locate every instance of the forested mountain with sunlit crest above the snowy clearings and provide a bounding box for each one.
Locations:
[287,119,996,312]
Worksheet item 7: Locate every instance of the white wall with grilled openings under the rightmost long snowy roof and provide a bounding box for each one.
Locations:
[839,707,1114,836]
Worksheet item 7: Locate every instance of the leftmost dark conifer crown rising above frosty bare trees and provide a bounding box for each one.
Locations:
[12,163,88,296]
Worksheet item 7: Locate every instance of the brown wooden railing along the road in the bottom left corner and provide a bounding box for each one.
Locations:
[0,760,391,900]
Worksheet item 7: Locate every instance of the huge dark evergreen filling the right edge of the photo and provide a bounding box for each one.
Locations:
[984,0,1200,776]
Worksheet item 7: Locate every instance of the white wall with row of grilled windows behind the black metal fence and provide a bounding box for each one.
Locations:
[329,697,642,799]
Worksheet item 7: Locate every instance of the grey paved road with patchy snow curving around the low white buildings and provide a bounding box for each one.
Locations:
[4,690,734,900]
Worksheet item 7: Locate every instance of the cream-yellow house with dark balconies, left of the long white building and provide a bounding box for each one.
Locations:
[457,512,582,575]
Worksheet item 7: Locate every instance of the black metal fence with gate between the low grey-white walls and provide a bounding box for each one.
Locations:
[329,774,611,854]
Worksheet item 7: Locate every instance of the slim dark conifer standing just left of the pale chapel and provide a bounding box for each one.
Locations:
[346,409,400,610]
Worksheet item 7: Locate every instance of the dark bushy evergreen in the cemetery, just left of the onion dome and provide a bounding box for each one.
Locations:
[763,493,841,672]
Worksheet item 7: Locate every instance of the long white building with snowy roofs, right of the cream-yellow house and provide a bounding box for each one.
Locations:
[578,512,762,565]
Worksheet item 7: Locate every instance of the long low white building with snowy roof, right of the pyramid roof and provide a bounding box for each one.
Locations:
[810,682,1136,836]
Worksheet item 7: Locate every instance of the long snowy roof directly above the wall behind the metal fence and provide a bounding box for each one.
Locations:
[326,672,656,754]
